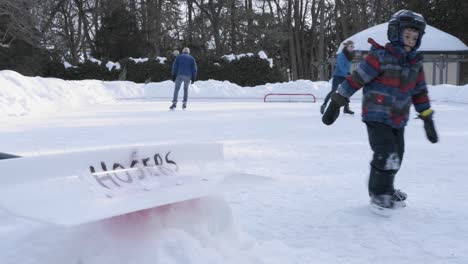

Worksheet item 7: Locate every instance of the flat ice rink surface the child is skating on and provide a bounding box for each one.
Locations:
[0,99,468,264]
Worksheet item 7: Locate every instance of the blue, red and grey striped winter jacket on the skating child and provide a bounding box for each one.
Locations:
[337,39,430,128]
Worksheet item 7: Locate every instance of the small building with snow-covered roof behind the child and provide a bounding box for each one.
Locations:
[337,23,468,85]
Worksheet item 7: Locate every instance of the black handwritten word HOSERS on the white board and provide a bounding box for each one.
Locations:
[82,151,180,197]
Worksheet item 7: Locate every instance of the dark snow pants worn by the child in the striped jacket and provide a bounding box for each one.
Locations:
[366,122,405,195]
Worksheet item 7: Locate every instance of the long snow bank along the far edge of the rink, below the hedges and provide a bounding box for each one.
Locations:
[0,71,468,117]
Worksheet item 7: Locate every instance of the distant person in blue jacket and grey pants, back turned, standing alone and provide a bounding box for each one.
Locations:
[169,47,198,110]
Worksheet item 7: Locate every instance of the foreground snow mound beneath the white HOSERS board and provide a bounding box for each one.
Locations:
[0,197,294,264]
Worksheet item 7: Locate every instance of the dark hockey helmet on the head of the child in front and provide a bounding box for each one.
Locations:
[387,9,426,50]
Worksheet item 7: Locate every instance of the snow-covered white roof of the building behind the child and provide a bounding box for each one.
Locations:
[337,22,468,53]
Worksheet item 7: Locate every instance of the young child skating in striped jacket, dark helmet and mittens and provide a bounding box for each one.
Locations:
[322,10,438,210]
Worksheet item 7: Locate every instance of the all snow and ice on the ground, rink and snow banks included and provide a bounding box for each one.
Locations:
[0,71,468,264]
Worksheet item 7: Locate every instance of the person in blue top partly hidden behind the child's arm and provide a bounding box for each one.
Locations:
[320,40,354,115]
